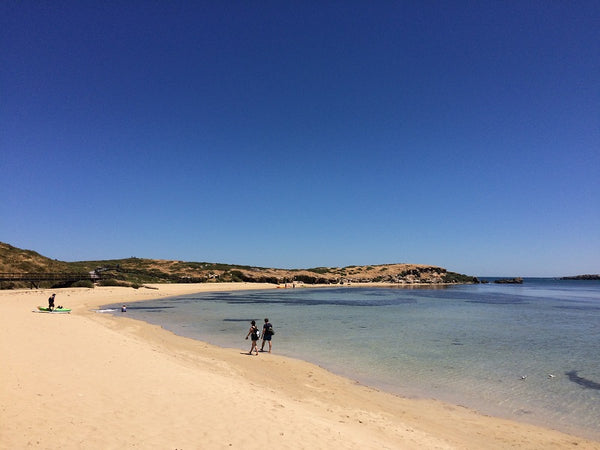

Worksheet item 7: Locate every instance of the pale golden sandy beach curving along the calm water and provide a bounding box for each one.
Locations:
[0,283,600,449]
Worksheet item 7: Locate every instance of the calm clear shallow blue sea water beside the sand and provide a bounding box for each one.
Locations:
[103,278,600,440]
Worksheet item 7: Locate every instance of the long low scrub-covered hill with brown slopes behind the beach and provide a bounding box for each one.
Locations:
[0,242,478,289]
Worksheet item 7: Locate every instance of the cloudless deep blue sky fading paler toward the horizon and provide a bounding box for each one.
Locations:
[0,0,600,276]
